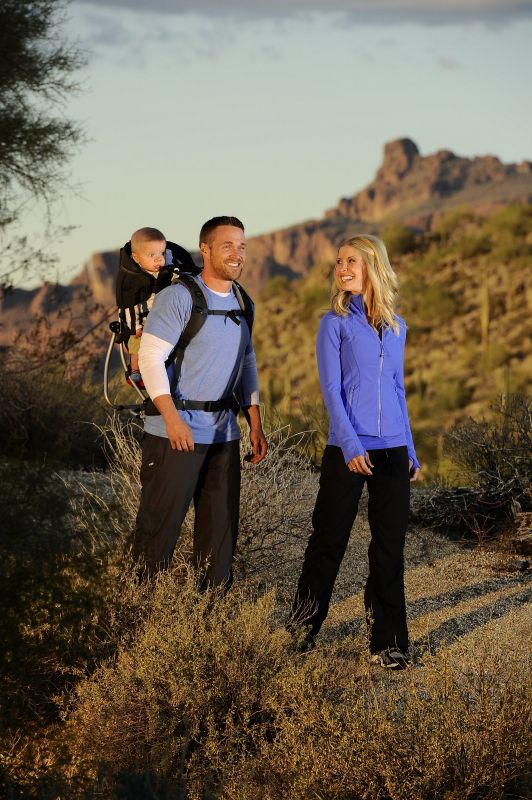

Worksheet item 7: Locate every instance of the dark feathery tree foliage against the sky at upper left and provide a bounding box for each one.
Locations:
[0,0,82,225]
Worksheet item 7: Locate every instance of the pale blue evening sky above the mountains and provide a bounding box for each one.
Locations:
[14,0,532,282]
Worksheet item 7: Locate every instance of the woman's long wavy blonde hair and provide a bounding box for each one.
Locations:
[331,233,399,333]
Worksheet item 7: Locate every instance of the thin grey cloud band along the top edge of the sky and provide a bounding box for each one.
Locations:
[75,0,532,24]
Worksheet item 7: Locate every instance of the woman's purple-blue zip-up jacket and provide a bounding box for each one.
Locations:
[316,295,419,467]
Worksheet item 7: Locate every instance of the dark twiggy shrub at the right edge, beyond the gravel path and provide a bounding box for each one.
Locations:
[417,395,532,541]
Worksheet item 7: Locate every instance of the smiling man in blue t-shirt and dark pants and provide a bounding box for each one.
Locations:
[133,217,266,588]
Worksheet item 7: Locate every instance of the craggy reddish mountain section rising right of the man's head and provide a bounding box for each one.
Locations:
[243,139,532,290]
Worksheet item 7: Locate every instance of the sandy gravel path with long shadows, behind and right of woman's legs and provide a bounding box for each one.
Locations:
[247,488,532,662]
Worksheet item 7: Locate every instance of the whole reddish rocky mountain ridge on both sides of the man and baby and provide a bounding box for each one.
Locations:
[0,138,532,344]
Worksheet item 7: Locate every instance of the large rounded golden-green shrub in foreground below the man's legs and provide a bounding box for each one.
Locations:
[64,572,294,789]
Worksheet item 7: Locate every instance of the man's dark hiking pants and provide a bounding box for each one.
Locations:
[133,433,240,587]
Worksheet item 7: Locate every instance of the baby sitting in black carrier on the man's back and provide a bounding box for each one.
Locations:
[116,228,199,388]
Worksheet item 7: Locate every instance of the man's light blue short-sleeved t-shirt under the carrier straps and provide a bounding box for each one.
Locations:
[144,278,258,444]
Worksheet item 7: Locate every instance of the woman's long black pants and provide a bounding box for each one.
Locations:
[292,445,410,653]
